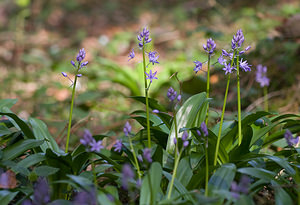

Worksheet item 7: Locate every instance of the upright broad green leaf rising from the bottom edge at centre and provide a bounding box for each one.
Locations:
[140,162,162,204]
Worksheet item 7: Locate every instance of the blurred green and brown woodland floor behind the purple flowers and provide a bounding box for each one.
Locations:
[0,0,300,147]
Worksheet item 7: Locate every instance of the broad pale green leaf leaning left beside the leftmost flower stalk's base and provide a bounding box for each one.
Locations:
[29,118,61,152]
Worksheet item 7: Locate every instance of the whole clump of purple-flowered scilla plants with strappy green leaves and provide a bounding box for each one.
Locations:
[0,29,300,205]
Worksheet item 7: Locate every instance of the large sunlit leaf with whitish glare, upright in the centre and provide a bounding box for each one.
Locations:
[166,92,207,153]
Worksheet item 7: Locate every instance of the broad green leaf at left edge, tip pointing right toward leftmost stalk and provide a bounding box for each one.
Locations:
[2,139,44,160]
